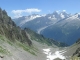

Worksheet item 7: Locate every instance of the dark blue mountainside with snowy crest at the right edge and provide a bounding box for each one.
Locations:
[41,14,80,45]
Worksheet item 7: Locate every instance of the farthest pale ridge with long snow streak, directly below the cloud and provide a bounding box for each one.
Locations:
[13,14,41,26]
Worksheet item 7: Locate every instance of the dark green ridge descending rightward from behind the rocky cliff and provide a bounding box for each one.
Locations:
[24,28,67,47]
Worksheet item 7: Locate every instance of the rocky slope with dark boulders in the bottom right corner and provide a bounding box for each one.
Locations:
[61,39,80,60]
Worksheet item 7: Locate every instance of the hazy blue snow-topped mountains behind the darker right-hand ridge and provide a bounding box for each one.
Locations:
[13,11,70,34]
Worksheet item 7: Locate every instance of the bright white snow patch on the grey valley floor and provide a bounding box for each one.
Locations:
[43,48,66,60]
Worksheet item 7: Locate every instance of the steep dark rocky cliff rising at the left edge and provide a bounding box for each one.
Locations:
[0,8,32,46]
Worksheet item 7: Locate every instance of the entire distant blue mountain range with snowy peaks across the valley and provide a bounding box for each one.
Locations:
[13,11,80,45]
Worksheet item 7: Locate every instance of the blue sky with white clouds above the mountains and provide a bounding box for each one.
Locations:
[0,0,80,18]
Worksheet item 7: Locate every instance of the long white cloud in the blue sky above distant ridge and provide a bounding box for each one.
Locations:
[12,8,41,18]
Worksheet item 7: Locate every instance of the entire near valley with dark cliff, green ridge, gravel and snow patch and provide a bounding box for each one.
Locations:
[0,8,80,60]
